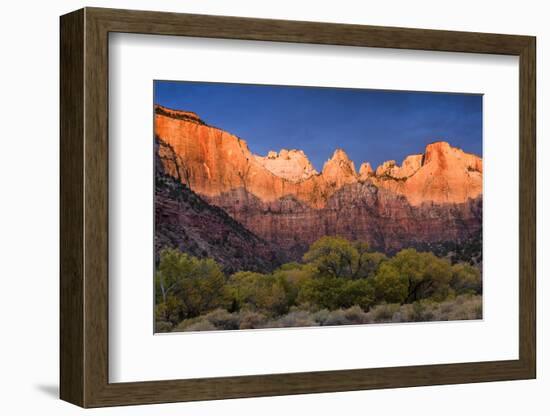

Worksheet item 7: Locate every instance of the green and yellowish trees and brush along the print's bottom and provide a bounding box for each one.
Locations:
[155,237,482,332]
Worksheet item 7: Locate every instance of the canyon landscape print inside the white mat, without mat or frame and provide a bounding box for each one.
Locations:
[152,81,483,333]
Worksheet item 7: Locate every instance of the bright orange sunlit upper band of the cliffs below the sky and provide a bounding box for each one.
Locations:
[155,107,482,208]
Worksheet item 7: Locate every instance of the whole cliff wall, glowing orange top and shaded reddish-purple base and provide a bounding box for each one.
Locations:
[155,107,483,253]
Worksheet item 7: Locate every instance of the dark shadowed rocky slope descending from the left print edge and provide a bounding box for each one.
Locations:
[155,140,283,273]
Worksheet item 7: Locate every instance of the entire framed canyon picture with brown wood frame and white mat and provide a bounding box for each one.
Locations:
[60,8,536,407]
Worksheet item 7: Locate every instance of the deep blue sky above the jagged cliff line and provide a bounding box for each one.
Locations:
[154,81,482,171]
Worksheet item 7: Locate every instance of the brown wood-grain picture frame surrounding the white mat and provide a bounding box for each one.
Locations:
[60,8,536,407]
